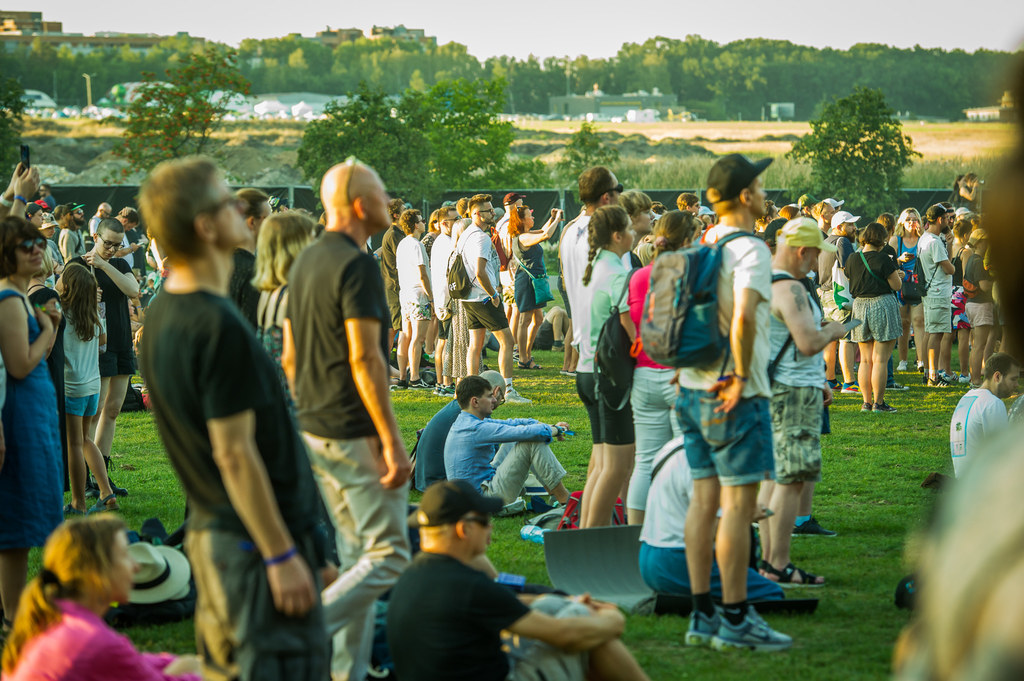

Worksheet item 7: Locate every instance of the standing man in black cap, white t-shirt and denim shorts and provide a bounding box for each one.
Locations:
[676,154,793,650]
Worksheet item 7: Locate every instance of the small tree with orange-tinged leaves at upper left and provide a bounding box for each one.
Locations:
[114,47,249,176]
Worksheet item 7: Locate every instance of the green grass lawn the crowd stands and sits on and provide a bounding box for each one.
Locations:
[46,342,963,681]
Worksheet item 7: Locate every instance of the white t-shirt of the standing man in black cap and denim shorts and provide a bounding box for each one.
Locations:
[679,224,771,397]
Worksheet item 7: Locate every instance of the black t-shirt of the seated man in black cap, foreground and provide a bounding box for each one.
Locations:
[387,552,529,681]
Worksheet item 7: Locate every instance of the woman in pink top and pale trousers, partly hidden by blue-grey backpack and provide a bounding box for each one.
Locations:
[626,211,703,524]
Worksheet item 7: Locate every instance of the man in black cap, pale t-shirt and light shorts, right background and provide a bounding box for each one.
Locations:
[918,204,955,387]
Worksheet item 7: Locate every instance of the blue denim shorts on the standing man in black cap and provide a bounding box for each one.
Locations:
[676,388,775,486]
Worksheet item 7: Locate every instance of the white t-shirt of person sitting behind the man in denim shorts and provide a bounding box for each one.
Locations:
[640,435,693,549]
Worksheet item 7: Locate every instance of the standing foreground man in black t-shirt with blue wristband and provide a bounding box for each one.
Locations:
[139,159,328,681]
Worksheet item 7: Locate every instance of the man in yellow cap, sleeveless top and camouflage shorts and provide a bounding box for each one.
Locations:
[760,217,846,587]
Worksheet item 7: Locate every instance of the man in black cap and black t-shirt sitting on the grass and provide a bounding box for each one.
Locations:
[387,480,647,681]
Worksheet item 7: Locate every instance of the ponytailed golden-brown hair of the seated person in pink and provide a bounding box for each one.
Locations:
[3,514,125,674]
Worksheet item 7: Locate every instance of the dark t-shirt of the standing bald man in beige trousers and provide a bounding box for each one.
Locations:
[288,231,391,439]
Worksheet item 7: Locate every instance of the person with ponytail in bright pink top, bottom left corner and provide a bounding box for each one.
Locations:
[3,515,200,681]
